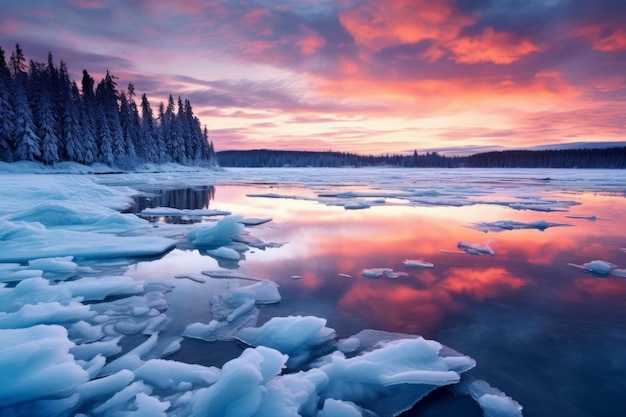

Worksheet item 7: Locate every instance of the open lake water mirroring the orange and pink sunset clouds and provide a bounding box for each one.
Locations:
[128,186,626,417]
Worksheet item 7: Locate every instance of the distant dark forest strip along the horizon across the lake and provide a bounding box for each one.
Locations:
[216,147,626,169]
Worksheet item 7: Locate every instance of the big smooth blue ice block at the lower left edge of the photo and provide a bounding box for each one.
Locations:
[0,325,89,408]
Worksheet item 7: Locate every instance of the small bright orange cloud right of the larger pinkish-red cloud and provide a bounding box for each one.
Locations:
[446,28,546,64]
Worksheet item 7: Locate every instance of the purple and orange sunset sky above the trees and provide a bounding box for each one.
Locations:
[0,0,626,154]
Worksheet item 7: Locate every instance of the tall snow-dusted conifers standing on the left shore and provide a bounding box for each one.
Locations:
[0,44,215,168]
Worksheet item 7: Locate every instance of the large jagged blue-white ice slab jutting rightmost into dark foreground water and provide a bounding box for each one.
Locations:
[319,332,475,415]
